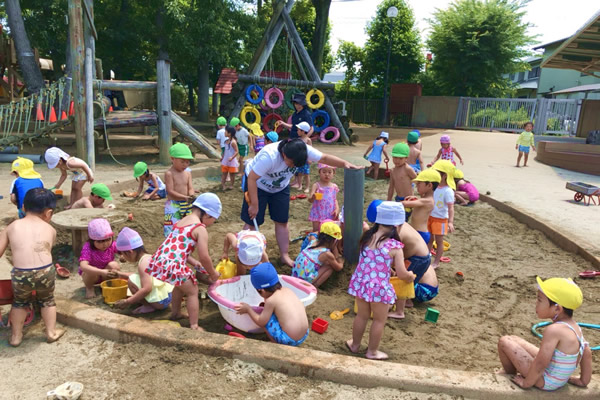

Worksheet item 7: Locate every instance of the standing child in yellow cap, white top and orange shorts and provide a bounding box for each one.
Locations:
[427,160,456,268]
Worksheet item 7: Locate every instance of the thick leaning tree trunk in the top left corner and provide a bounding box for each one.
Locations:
[4,0,44,93]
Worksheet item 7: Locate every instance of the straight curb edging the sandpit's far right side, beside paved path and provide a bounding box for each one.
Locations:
[479,194,600,269]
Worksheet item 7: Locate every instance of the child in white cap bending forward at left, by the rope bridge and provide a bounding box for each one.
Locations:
[44,147,94,210]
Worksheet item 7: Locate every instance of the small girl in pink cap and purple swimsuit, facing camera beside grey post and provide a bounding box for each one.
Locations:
[308,164,340,232]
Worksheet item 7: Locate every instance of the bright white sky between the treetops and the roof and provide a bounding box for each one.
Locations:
[329,0,600,54]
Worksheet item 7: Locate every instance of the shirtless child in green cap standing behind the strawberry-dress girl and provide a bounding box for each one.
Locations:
[163,143,194,237]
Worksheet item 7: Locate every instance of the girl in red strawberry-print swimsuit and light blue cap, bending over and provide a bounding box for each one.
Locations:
[146,193,222,330]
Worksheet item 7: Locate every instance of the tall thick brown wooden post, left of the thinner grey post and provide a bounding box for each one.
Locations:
[69,0,87,161]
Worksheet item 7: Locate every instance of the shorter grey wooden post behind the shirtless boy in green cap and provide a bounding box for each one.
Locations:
[156,60,172,165]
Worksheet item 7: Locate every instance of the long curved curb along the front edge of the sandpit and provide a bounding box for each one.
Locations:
[57,298,600,400]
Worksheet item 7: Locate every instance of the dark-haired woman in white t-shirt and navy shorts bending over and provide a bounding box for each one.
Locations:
[241,139,360,267]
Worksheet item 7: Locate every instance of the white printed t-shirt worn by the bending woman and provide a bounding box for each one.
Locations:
[247,142,323,193]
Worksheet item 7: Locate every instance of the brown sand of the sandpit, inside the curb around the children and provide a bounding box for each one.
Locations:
[43,171,600,371]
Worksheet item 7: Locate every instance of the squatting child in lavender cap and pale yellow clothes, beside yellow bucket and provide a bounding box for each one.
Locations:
[115,227,173,314]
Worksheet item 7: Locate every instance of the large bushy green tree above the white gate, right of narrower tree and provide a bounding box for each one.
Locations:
[427,0,533,97]
